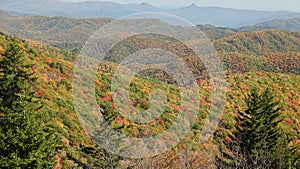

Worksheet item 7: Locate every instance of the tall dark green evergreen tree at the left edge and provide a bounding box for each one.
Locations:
[0,38,54,169]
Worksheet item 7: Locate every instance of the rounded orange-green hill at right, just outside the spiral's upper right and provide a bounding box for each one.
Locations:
[214,30,300,55]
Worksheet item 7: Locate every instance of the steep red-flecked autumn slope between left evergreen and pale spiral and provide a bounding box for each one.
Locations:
[0,33,119,168]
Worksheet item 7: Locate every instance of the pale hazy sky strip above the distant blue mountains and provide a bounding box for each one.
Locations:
[65,0,300,12]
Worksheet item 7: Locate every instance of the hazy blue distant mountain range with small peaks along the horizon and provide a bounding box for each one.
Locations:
[0,0,300,28]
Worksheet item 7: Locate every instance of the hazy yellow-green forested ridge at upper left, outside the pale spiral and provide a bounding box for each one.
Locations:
[0,11,112,52]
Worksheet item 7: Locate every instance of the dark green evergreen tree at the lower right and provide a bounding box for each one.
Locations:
[216,89,287,168]
